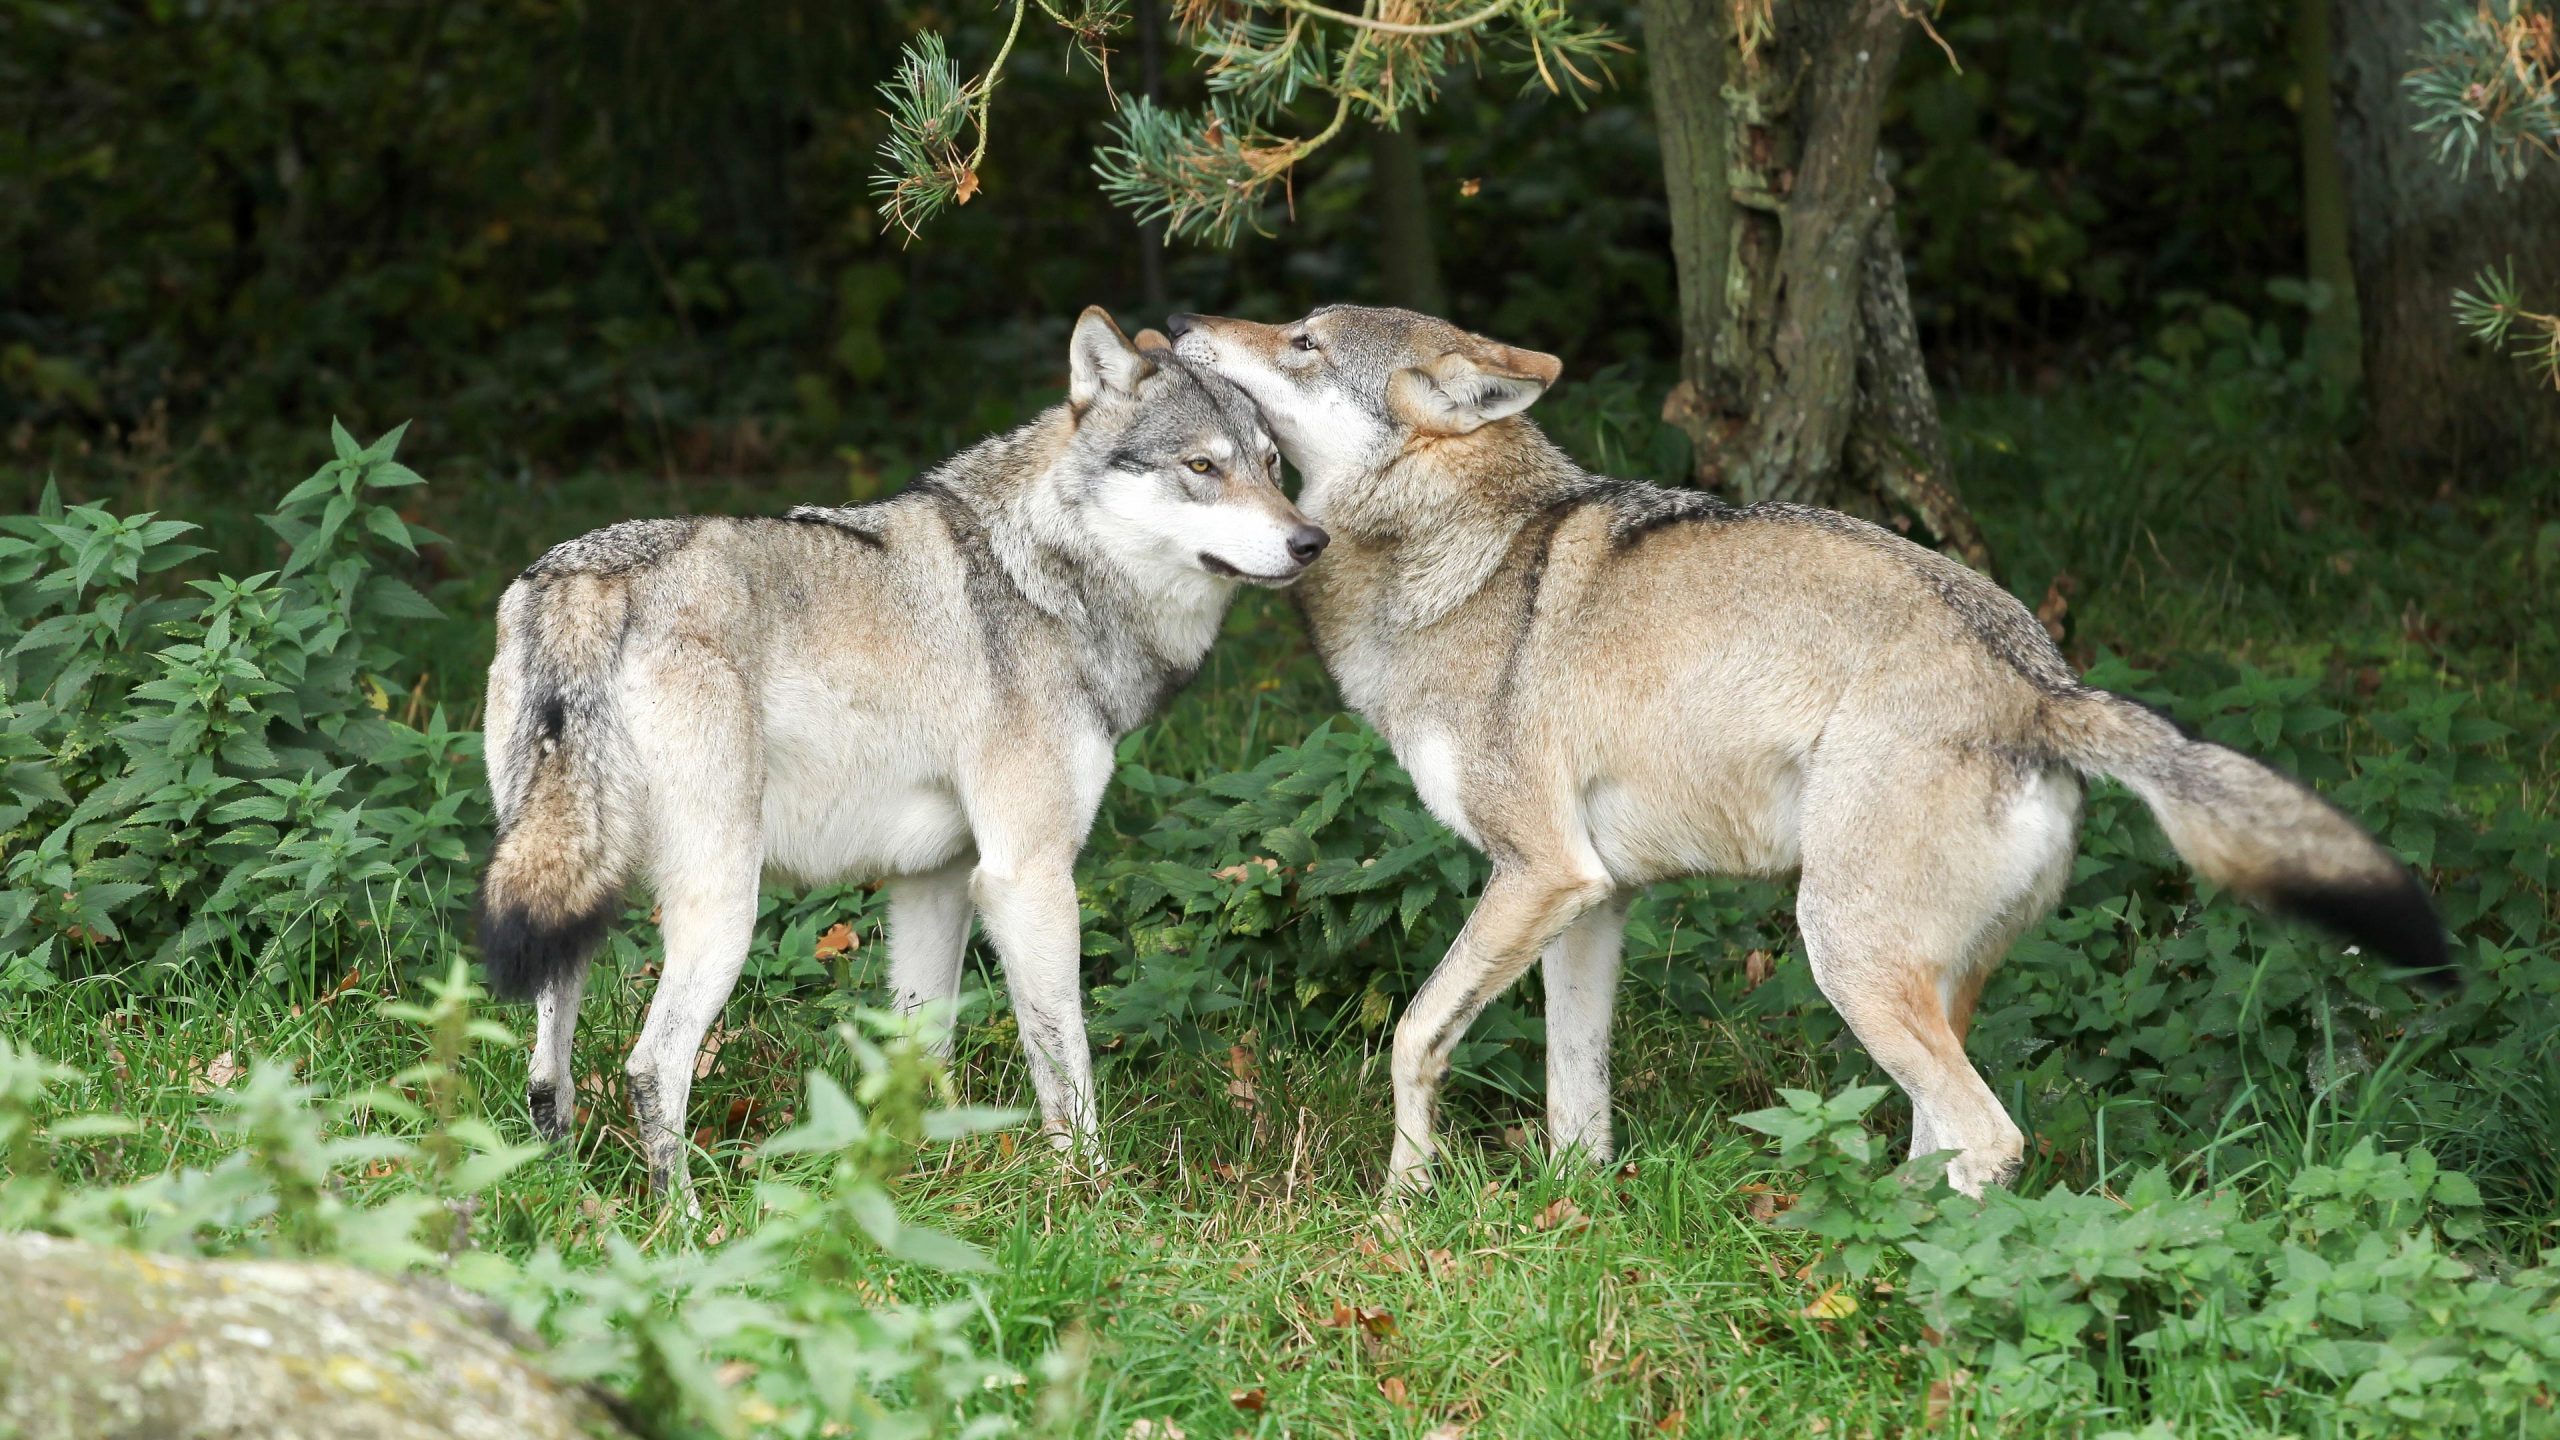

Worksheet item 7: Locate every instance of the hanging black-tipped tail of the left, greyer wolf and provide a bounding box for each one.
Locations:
[474,574,637,999]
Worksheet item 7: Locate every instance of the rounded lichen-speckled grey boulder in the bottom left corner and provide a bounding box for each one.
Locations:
[0,1219,630,1440]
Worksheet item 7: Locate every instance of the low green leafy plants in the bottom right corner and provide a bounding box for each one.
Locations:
[1741,1086,2560,1435]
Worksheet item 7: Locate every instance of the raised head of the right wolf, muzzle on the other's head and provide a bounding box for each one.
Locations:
[1165,305,1564,499]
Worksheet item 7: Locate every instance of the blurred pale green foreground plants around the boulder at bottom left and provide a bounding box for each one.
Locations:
[0,966,1062,1440]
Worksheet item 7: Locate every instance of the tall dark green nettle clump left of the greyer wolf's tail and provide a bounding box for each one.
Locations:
[0,425,489,994]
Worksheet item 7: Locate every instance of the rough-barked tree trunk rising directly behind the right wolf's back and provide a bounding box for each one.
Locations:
[1644,0,1989,566]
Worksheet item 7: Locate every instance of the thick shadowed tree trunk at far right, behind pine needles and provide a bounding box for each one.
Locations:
[2335,0,2560,474]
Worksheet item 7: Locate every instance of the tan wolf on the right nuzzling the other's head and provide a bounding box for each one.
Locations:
[1165,305,2452,1194]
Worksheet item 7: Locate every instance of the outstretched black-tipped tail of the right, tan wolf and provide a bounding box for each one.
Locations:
[2045,689,2463,994]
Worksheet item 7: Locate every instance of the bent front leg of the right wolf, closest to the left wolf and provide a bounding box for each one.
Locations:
[1388,863,1610,1189]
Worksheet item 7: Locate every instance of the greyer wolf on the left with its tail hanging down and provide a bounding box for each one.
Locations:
[476,307,1326,1199]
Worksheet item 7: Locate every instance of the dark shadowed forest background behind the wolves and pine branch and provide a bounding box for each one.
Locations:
[0,0,2304,502]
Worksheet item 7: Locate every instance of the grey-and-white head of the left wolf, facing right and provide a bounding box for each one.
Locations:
[1068,305,1326,584]
